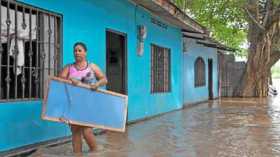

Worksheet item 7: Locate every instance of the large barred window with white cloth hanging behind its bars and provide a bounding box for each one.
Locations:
[0,0,62,101]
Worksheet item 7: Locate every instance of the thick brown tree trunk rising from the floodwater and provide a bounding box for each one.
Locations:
[234,0,280,97]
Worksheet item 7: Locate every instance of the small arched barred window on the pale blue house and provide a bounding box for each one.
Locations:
[194,57,205,87]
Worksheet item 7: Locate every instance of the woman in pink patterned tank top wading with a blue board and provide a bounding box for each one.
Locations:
[59,42,107,153]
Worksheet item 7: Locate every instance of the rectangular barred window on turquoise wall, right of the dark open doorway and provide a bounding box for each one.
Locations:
[151,44,171,93]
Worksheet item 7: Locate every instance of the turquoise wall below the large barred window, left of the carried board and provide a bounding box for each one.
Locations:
[0,101,69,152]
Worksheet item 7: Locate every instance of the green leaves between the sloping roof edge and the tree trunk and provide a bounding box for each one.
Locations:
[173,0,248,56]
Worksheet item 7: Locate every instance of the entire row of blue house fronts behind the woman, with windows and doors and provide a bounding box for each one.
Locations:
[0,0,221,154]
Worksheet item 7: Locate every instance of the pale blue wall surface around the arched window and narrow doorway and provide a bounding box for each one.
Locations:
[183,38,218,104]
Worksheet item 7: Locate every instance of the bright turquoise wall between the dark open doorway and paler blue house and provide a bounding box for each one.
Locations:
[128,4,183,121]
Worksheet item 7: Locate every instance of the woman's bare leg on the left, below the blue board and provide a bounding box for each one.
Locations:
[70,125,82,153]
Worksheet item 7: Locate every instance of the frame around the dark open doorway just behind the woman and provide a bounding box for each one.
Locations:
[105,28,128,95]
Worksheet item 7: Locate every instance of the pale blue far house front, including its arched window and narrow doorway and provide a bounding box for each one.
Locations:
[183,38,219,104]
